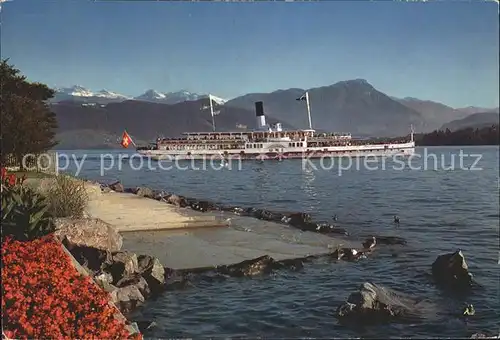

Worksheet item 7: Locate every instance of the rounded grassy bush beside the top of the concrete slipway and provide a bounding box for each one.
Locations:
[46,175,89,218]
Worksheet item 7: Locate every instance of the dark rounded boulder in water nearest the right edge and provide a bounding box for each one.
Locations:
[432,250,473,289]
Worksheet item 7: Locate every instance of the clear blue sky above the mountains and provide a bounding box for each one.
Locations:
[1,0,499,107]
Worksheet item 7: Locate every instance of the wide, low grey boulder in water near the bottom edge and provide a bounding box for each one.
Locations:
[336,282,416,323]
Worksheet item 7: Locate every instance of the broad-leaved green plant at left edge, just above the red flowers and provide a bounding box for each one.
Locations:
[2,185,55,240]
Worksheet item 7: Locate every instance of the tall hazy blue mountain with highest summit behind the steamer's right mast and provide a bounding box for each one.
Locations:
[225,79,424,136]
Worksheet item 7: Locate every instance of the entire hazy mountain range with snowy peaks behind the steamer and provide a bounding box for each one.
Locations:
[52,79,496,145]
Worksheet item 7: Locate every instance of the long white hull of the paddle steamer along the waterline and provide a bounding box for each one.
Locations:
[137,142,415,161]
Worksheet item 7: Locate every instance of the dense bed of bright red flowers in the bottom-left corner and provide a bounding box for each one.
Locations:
[2,235,141,339]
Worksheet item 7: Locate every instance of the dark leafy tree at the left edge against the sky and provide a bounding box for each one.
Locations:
[0,60,57,167]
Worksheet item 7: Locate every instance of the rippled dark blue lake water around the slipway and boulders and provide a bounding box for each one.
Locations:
[56,147,500,338]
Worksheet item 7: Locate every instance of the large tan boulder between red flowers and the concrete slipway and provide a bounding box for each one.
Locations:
[55,218,123,252]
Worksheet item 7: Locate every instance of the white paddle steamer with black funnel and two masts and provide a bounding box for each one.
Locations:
[133,92,415,160]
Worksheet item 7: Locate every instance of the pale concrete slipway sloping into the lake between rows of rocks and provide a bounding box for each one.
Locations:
[88,185,353,269]
